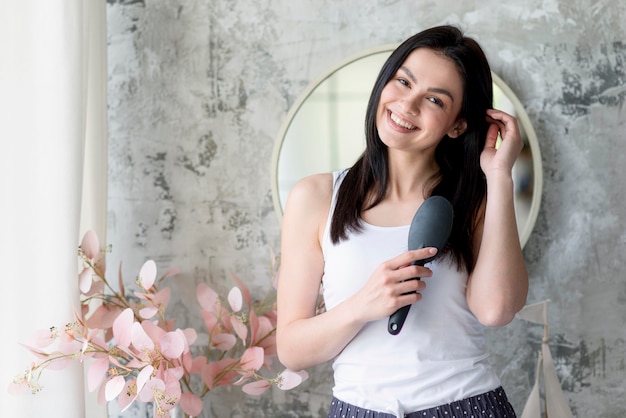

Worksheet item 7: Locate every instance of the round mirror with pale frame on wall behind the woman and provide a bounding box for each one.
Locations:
[272,45,543,246]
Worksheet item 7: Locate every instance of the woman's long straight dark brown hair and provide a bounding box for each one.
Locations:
[330,26,493,272]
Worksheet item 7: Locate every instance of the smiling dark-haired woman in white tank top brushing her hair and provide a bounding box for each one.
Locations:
[277,26,528,417]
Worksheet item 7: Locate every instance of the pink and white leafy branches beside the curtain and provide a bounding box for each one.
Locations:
[9,231,308,417]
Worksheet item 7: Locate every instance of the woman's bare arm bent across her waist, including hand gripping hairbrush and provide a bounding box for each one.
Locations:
[277,175,432,370]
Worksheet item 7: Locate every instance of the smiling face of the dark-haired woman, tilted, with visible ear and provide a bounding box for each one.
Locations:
[376,48,466,152]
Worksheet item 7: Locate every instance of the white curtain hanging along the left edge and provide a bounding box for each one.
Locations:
[0,0,107,418]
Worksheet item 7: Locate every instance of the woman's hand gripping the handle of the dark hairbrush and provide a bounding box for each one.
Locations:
[351,248,437,323]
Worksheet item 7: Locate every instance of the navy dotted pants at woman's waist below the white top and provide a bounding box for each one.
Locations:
[328,387,516,418]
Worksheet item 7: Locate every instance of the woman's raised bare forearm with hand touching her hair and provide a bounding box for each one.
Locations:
[467,110,528,326]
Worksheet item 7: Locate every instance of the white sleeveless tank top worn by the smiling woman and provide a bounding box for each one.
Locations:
[322,170,500,417]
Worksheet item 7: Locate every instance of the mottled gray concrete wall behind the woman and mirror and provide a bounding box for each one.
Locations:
[107,0,626,418]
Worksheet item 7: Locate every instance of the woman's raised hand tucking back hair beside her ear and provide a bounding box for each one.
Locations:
[480,109,524,175]
